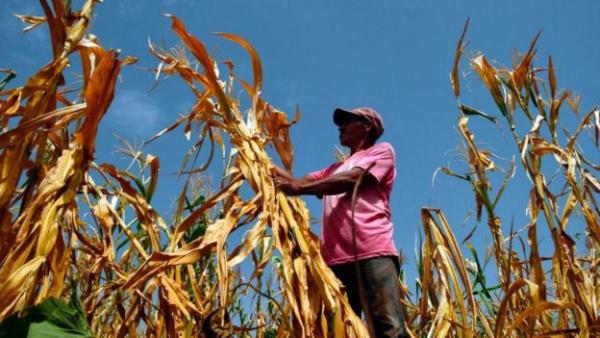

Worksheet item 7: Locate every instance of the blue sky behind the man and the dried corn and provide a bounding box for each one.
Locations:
[0,0,600,296]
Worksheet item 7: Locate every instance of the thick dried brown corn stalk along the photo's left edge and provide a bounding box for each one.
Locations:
[0,0,132,318]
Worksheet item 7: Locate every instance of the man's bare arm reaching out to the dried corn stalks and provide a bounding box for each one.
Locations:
[273,167,377,196]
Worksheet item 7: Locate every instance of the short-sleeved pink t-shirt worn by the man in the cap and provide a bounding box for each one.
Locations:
[309,142,398,265]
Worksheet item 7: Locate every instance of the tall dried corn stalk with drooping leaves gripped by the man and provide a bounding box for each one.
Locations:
[124,17,366,337]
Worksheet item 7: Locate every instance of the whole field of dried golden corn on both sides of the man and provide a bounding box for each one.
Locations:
[0,0,600,337]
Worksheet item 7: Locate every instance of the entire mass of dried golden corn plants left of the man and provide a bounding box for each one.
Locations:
[0,0,366,337]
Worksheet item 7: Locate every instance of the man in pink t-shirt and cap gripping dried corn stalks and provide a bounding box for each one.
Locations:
[273,107,407,337]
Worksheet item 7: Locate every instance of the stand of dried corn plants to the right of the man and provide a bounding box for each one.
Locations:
[410,19,600,337]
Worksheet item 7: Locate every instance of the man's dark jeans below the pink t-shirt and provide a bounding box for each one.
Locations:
[330,256,408,338]
